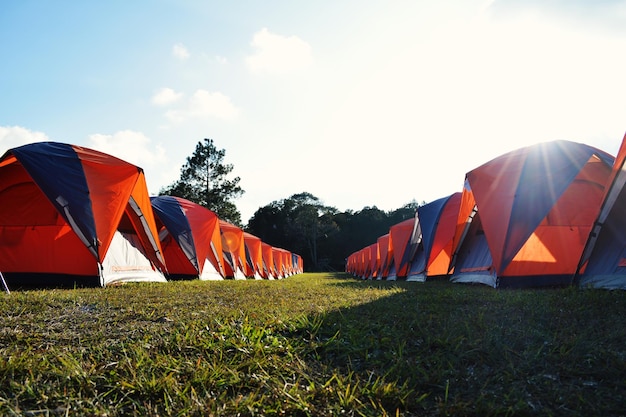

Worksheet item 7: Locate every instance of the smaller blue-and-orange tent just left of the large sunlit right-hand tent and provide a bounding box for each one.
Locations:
[407,192,461,282]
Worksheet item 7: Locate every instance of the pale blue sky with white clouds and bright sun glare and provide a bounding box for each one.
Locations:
[0,0,626,223]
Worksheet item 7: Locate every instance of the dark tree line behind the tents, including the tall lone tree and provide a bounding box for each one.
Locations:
[159,139,418,271]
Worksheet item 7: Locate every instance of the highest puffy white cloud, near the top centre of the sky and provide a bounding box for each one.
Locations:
[246,28,313,74]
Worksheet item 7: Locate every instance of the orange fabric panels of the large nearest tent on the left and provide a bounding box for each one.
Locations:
[0,147,163,276]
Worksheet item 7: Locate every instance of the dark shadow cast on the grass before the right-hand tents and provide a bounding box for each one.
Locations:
[291,274,626,416]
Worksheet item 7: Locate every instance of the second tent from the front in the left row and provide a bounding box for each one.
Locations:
[151,196,225,280]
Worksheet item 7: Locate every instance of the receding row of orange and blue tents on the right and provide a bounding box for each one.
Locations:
[346,136,626,289]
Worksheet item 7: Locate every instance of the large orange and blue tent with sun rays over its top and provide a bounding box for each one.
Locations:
[451,141,613,287]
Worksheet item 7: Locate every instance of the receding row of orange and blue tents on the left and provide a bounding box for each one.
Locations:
[0,142,303,290]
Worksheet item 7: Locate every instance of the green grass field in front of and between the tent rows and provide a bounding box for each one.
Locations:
[0,274,626,416]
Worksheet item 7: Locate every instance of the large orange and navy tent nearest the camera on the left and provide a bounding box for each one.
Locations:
[0,142,165,286]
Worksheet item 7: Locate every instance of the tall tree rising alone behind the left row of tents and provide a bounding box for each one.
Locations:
[159,138,244,226]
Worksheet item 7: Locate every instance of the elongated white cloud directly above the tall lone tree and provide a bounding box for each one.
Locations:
[165,90,239,123]
